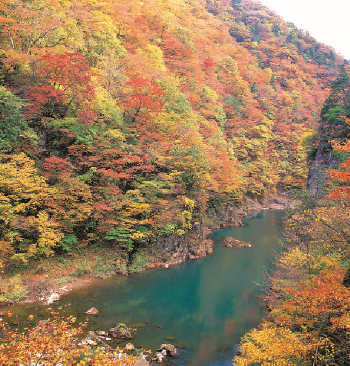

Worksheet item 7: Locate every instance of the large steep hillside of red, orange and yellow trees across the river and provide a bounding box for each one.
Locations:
[0,0,344,263]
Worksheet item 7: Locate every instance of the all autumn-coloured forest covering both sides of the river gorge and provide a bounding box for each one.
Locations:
[0,0,350,365]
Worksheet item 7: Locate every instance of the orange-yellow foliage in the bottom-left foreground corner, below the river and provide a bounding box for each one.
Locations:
[0,312,137,366]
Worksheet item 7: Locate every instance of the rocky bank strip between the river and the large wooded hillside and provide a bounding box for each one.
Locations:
[0,195,293,305]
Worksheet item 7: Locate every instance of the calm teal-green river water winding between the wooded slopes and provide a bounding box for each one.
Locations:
[1,210,285,366]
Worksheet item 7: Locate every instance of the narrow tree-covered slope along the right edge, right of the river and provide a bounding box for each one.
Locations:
[236,68,350,366]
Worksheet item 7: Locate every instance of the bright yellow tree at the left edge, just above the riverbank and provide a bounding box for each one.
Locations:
[0,153,63,262]
